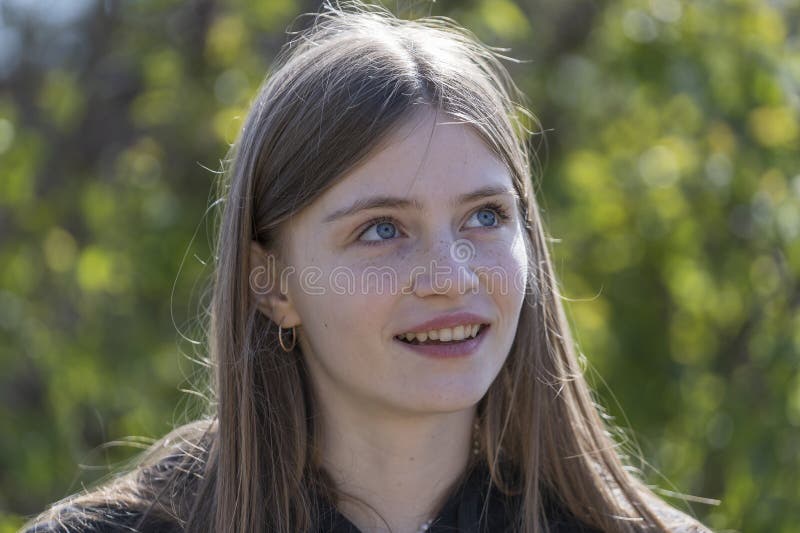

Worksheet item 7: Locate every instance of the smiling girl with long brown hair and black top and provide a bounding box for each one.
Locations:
[28,3,708,533]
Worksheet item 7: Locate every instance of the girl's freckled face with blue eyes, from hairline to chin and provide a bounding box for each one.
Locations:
[273,110,528,414]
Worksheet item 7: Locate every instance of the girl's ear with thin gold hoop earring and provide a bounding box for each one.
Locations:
[248,241,300,328]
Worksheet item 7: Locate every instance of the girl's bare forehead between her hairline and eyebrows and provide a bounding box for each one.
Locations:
[306,110,513,217]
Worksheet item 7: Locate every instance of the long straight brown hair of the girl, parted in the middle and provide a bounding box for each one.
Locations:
[28,2,702,533]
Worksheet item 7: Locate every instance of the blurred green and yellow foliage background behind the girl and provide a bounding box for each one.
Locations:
[0,0,800,533]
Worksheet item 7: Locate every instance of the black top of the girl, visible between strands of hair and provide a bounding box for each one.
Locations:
[25,467,601,533]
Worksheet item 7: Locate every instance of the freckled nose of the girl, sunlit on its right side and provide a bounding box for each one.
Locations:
[411,239,479,298]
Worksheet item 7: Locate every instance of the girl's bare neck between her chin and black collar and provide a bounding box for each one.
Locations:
[322,407,475,533]
